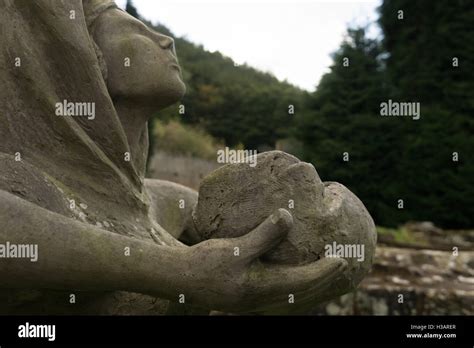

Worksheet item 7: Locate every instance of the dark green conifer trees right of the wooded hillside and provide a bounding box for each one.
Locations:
[297,0,474,228]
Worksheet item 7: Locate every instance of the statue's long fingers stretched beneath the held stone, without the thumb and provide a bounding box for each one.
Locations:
[243,258,347,313]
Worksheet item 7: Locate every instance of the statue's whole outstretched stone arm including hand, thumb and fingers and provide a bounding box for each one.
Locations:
[0,190,347,313]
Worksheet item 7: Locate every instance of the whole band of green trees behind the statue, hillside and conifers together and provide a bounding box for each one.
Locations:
[134,0,474,228]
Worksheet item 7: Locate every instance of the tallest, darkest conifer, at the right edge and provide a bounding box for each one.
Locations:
[380,0,474,228]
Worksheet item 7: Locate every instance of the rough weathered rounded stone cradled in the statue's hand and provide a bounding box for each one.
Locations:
[193,151,376,298]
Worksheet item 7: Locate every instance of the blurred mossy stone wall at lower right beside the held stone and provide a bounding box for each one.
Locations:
[314,246,474,315]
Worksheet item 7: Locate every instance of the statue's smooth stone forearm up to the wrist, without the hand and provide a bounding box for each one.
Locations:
[0,190,184,298]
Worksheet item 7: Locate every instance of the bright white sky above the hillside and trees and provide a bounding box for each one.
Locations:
[116,0,380,90]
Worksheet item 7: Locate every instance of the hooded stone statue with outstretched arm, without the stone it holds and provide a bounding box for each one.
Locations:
[0,0,370,314]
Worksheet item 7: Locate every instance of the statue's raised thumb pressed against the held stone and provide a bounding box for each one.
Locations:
[236,209,293,260]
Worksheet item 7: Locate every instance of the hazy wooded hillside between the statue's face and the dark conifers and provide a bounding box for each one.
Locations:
[145,21,306,149]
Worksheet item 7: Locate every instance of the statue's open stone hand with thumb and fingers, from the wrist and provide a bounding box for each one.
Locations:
[178,209,347,314]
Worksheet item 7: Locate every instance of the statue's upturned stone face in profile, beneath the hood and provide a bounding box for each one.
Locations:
[93,8,185,108]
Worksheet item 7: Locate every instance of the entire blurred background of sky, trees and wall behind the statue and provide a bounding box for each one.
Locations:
[117,0,474,315]
